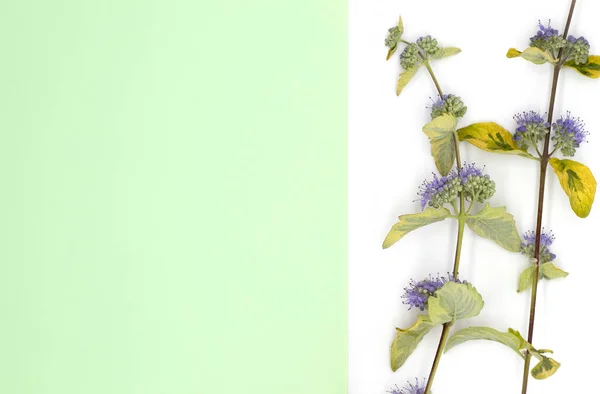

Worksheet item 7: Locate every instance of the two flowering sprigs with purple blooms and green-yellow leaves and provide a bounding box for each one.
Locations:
[383,0,600,394]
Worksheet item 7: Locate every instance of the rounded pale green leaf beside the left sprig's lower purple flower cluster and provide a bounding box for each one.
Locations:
[427,282,483,324]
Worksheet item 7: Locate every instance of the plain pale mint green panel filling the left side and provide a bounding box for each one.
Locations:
[0,0,347,394]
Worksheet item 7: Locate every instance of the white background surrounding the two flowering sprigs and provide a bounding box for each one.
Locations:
[349,0,600,394]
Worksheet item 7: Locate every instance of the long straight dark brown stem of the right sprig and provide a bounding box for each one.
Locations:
[521,0,577,394]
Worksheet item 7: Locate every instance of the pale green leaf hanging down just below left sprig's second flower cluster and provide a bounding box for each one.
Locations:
[423,114,458,176]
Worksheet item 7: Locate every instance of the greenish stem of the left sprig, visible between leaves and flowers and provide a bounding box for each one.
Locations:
[424,60,467,394]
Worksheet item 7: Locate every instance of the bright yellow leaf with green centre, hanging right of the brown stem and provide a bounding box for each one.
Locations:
[550,158,596,218]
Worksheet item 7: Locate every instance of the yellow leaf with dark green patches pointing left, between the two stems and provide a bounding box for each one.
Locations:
[458,122,536,160]
